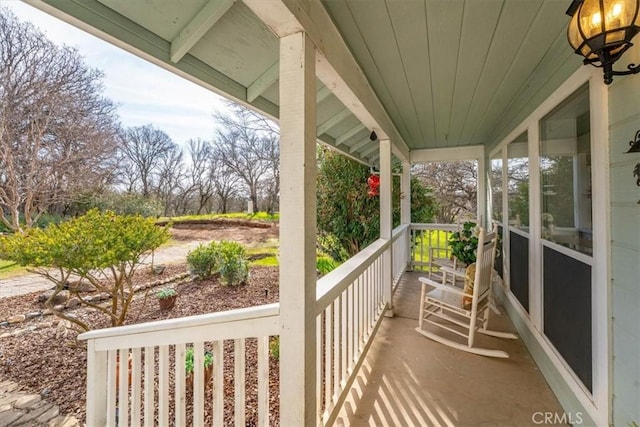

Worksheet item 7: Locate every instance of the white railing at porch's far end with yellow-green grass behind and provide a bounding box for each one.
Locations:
[411,224,458,271]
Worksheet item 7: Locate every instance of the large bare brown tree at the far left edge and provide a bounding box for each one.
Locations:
[0,8,118,230]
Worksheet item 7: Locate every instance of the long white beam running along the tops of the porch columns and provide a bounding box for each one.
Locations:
[244,0,409,160]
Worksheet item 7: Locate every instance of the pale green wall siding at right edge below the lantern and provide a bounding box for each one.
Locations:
[609,44,640,426]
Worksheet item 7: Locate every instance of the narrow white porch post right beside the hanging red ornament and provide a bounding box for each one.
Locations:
[380,139,393,316]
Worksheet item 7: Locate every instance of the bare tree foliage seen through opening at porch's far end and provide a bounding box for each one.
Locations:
[412,161,478,224]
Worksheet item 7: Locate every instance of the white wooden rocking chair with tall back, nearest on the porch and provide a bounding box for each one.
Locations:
[416,229,517,358]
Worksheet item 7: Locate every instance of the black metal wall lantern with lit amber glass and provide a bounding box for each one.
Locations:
[567,0,640,84]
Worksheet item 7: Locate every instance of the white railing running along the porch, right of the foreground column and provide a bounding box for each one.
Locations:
[316,225,409,424]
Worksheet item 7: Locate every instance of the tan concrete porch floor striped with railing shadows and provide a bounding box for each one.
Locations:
[336,272,563,427]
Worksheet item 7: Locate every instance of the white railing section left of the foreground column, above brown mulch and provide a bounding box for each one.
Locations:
[79,304,279,426]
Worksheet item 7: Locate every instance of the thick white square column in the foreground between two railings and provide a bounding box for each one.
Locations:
[280,33,316,426]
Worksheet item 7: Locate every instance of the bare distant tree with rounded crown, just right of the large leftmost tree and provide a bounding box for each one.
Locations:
[120,124,175,197]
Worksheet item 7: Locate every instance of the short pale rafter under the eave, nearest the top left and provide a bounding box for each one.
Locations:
[170,0,236,63]
